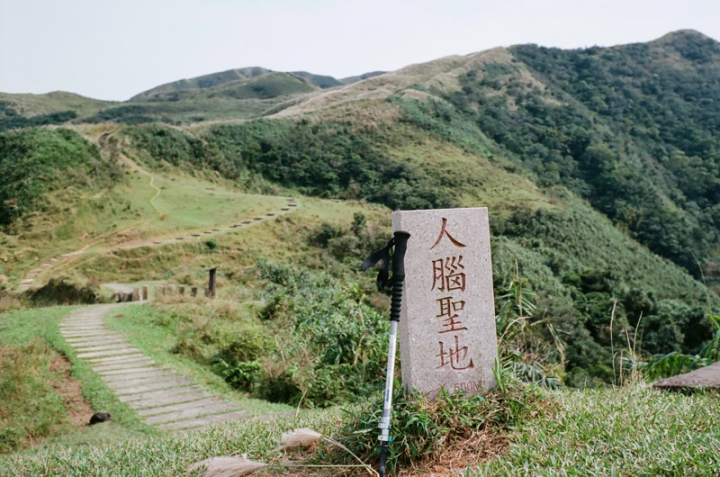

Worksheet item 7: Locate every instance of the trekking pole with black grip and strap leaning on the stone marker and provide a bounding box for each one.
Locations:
[361,231,410,477]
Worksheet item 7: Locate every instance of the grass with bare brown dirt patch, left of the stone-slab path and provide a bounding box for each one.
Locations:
[0,307,155,452]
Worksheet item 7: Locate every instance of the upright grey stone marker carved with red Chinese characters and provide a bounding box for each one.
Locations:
[392,207,497,398]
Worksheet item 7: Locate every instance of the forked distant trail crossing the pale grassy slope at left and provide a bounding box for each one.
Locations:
[18,152,298,292]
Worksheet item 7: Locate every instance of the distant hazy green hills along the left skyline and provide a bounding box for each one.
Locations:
[0,67,394,131]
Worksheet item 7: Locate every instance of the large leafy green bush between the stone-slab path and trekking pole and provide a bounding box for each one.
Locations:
[211,262,389,407]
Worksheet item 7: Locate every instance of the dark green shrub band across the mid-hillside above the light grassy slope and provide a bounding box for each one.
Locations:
[129,120,455,209]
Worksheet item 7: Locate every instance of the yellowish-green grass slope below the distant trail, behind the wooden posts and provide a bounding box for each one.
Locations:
[68,197,390,286]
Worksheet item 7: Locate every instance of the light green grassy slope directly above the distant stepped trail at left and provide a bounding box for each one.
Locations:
[6,159,286,283]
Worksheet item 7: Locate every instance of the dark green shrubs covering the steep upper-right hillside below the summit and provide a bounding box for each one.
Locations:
[446,32,720,277]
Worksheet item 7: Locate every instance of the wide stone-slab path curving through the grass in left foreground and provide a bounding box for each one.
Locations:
[60,305,249,431]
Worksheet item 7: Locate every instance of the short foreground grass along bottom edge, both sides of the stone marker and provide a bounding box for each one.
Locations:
[0,384,720,477]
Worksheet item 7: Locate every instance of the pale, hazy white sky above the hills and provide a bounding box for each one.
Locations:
[0,0,720,101]
